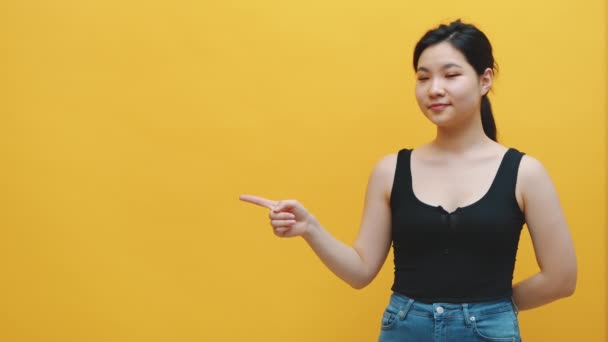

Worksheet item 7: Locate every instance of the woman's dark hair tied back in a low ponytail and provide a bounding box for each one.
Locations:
[414,19,498,141]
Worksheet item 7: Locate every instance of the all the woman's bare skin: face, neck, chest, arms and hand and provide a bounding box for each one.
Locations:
[240,42,577,310]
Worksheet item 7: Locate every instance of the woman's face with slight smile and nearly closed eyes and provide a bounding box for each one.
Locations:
[416,42,493,126]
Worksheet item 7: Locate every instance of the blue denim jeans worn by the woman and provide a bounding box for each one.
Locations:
[378,293,521,342]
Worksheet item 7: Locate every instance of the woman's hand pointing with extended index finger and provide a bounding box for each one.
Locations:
[239,195,314,237]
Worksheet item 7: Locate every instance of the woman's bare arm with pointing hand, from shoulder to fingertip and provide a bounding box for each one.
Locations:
[241,155,396,289]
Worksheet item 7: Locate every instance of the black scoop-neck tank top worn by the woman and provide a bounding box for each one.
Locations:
[390,148,525,303]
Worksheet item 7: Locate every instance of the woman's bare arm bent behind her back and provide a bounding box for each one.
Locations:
[513,156,577,310]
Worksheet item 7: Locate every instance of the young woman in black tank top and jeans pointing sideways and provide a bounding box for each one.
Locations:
[241,20,577,342]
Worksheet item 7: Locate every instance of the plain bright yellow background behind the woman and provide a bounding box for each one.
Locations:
[0,0,608,342]
